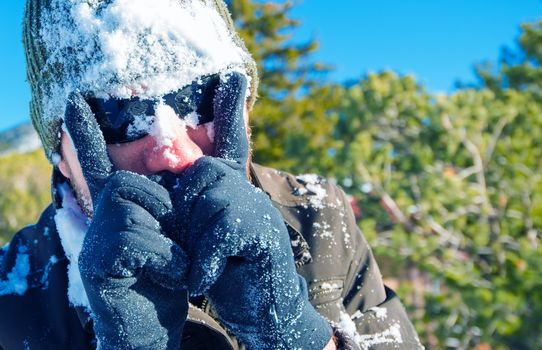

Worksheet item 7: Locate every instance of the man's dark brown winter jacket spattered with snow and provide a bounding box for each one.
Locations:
[0,164,422,350]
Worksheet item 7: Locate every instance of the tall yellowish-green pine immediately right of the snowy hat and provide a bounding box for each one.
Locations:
[231,0,340,172]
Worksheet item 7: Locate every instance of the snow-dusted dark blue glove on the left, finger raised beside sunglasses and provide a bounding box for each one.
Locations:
[65,93,188,350]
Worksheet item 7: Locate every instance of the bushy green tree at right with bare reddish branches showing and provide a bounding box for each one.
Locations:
[333,72,542,349]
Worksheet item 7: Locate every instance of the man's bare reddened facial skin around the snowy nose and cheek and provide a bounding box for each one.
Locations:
[58,106,248,214]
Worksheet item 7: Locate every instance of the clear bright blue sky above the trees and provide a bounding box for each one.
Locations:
[0,0,542,130]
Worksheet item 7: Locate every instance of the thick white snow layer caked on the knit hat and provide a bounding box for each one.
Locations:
[39,0,251,125]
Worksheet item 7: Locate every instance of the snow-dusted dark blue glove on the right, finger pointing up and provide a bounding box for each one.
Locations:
[172,73,332,349]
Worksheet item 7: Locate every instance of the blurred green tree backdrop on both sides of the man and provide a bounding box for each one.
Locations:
[0,0,542,350]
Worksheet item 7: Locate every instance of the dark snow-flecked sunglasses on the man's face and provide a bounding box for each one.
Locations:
[86,74,220,144]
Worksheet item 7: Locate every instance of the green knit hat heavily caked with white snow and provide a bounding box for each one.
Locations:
[23,0,258,164]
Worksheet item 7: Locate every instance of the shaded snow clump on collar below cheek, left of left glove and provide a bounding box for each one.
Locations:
[55,183,90,309]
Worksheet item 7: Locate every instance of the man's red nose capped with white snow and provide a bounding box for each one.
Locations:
[146,102,203,173]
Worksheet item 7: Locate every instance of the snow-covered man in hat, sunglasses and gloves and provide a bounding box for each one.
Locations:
[0,0,421,349]
